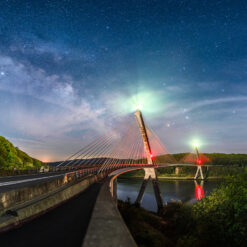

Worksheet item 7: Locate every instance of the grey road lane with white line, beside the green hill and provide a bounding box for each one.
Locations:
[0,172,65,193]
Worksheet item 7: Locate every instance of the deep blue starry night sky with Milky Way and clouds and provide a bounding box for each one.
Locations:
[0,0,247,161]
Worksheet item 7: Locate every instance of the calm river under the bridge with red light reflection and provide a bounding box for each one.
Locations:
[117,178,221,211]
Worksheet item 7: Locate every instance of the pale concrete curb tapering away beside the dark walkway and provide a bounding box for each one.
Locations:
[82,178,137,247]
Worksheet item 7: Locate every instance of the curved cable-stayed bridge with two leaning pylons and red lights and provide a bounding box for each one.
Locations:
[0,110,209,246]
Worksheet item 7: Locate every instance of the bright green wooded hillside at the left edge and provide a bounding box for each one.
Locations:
[0,136,43,170]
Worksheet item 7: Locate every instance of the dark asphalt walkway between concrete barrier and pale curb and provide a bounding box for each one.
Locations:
[0,183,101,247]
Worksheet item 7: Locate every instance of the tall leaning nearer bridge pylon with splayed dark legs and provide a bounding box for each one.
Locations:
[135,110,164,212]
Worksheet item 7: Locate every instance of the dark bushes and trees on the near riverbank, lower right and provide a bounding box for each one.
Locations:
[119,172,247,247]
